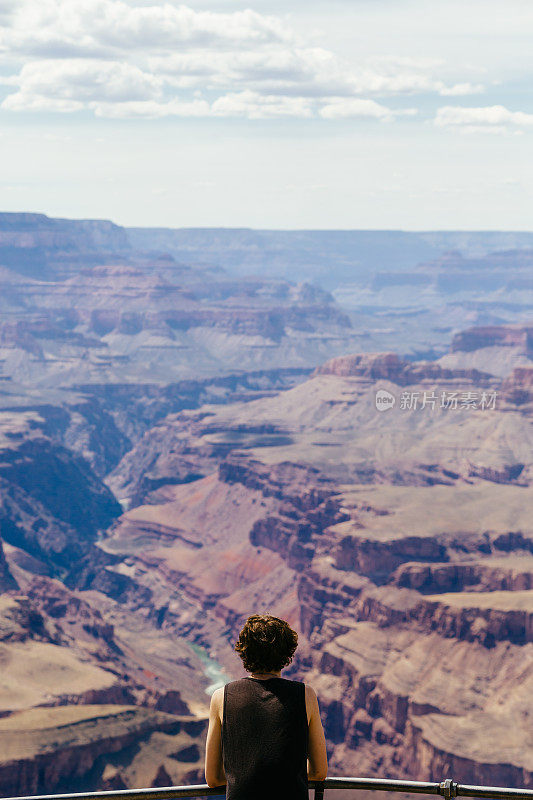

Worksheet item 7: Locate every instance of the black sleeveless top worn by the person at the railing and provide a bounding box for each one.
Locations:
[222,678,309,800]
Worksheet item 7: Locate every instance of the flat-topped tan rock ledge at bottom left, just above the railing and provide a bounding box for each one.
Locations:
[0,705,205,795]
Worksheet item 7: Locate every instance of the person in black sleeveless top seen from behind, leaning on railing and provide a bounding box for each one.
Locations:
[205,614,328,800]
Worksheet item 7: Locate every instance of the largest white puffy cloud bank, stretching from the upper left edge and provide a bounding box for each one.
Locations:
[0,0,482,119]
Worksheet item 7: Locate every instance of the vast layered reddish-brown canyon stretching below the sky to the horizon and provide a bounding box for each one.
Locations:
[0,215,533,795]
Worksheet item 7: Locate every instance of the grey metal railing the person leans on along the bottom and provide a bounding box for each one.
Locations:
[2,778,533,800]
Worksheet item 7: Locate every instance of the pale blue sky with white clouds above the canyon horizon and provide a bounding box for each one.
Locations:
[0,0,533,230]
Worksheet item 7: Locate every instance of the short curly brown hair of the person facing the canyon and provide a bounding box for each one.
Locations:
[235,614,298,672]
